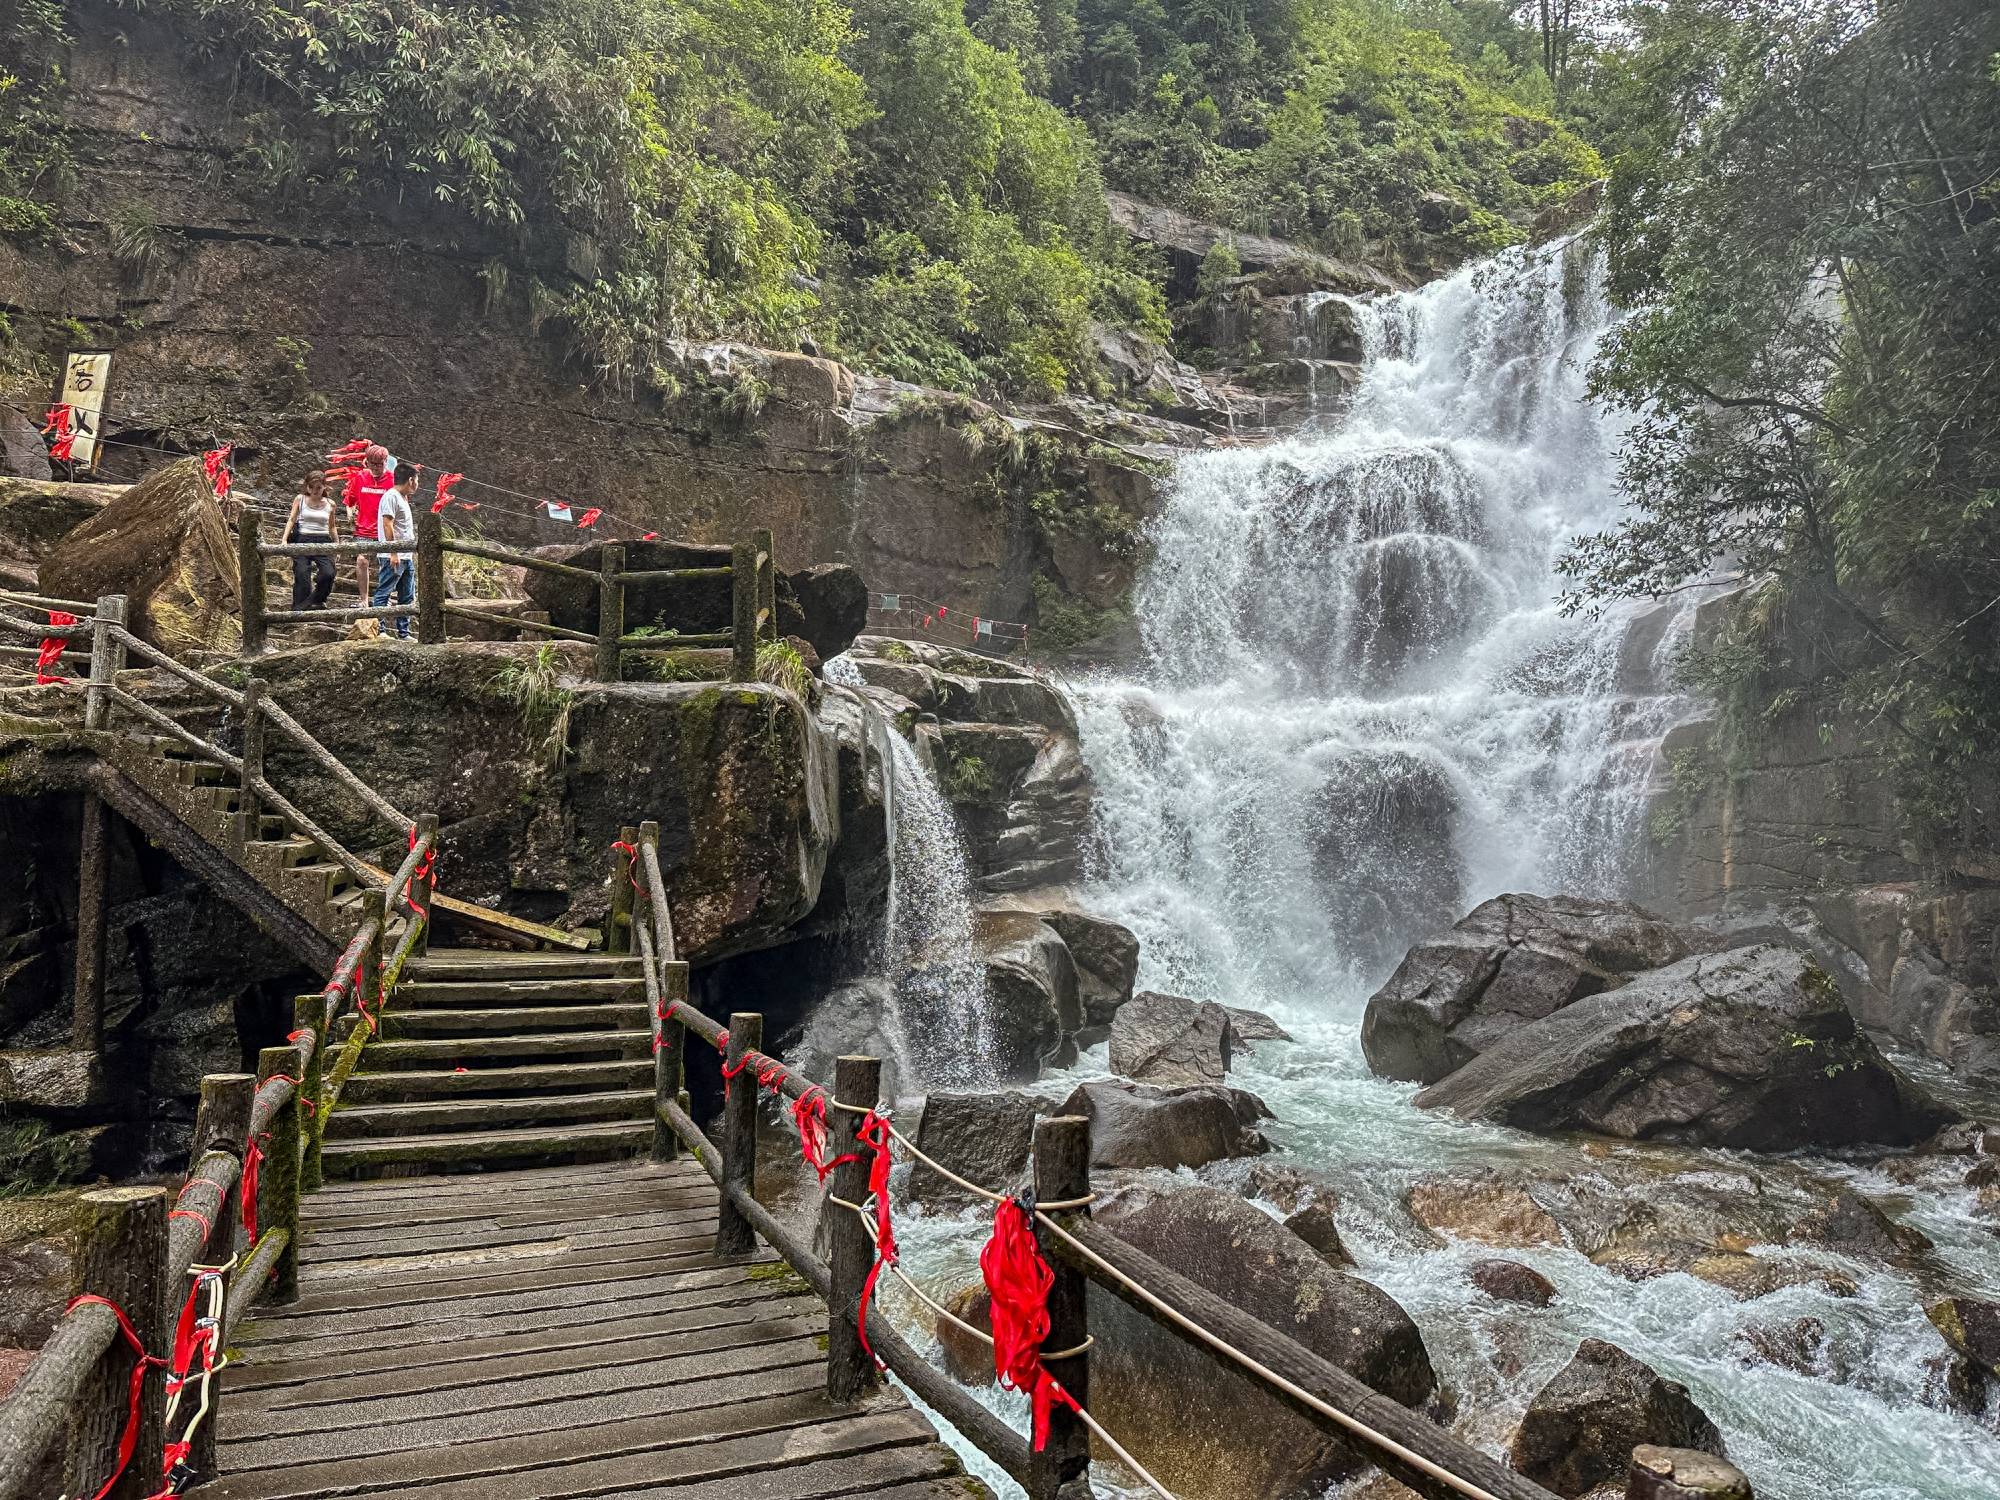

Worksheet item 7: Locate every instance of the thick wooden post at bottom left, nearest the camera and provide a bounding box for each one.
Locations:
[66,1188,178,1500]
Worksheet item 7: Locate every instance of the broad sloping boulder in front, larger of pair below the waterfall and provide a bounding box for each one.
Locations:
[1416,944,1950,1152]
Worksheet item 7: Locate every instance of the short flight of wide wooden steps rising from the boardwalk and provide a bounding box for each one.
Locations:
[322,948,654,1178]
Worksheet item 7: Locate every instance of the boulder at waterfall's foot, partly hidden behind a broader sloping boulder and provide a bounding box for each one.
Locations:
[1362,896,1688,1084]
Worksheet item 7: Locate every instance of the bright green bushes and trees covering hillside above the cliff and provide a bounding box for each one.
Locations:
[0,0,1598,394]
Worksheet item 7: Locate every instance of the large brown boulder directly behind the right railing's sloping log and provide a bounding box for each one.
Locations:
[1090,1184,1436,1500]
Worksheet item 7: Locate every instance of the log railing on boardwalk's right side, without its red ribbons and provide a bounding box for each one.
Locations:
[614,848,1556,1500]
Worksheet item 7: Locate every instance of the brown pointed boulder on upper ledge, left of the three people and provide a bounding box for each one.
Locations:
[40,458,242,656]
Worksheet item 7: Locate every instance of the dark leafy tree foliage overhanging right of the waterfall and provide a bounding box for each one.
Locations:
[1566,0,2000,858]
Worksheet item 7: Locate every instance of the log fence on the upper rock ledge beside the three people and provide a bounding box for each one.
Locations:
[236,506,778,682]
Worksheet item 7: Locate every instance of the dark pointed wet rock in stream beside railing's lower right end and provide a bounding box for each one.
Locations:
[1508,1338,1724,1498]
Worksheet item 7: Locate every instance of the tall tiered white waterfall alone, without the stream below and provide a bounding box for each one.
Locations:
[1082,248,1684,1010]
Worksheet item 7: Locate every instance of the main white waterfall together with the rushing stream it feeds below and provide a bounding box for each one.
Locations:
[1078,246,2000,1500]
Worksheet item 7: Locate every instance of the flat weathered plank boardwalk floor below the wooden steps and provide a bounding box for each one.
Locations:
[196,1160,986,1500]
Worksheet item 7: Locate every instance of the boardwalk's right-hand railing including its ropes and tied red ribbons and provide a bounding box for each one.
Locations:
[614,840,1554,1500]
